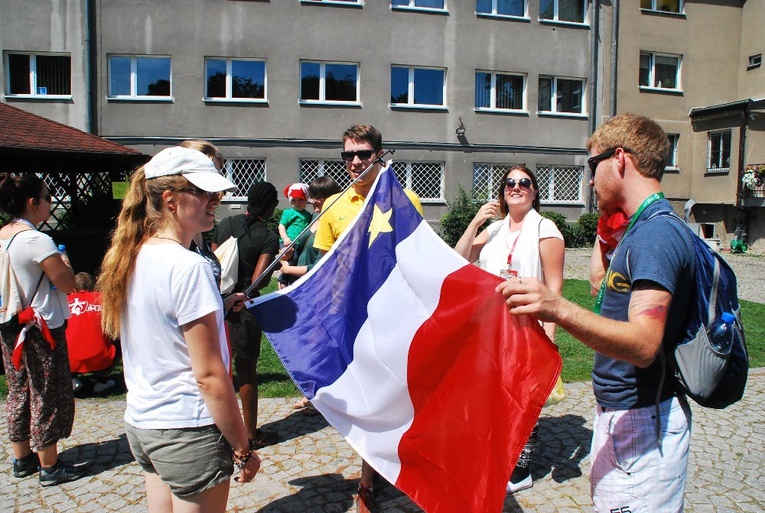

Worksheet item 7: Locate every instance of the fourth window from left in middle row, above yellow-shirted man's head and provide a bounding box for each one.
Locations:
[300,61,359,104]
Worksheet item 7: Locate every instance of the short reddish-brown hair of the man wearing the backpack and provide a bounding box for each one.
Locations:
[587,114,670,180]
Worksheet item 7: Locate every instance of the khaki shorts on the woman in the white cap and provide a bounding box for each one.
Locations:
[125,423,234,498]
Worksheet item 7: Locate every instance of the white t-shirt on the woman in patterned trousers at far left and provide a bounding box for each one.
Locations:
[0,230,69,328]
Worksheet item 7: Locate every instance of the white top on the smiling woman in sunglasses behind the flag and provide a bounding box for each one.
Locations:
[478,209,563,281]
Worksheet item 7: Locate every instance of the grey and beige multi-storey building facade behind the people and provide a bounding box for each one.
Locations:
[0,0,765,248]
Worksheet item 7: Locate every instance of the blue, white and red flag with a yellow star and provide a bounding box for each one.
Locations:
[248,168,561,513]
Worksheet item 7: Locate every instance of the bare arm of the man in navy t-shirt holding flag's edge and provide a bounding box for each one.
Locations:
[496,278,672,367]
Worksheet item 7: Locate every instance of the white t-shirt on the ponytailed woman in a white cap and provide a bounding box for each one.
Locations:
[120,244,230,429]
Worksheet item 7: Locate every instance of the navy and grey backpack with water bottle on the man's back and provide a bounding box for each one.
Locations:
[658,212,749,408]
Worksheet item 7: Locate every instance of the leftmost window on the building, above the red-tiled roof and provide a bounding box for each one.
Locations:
[6,53,72,97]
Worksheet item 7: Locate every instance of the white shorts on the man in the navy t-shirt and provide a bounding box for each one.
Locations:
[590,397,691,513]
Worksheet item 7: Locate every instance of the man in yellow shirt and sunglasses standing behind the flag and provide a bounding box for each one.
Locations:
[313,125,422,513]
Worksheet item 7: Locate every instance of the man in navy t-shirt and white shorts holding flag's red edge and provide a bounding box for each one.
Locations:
[497,114,695,513]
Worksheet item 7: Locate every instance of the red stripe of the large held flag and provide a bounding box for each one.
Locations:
[396,265,561,513]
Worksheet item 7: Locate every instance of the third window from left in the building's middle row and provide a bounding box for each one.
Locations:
[205,59,266,100]
